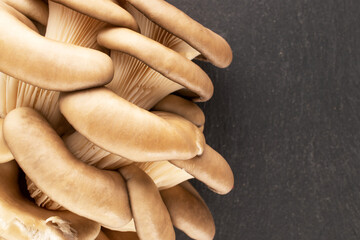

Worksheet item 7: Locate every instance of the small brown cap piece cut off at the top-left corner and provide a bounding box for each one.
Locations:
[2,0,49,26]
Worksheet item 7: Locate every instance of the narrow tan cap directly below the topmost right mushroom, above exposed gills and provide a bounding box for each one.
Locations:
[97,28,214,101]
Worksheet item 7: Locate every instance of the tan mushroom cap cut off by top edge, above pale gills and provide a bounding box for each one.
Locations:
[53,0,139,31]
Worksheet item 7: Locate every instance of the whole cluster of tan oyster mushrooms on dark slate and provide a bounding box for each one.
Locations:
[0,0,234,240]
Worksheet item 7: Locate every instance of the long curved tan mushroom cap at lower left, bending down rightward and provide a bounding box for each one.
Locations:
[3,108,131,229]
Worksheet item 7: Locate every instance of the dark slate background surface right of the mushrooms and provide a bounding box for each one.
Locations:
[169,0,360,240]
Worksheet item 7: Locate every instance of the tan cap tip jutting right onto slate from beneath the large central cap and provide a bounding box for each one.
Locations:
[170,145,234,194]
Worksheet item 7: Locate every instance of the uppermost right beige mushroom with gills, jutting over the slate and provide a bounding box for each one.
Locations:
[121,0,232,67]
